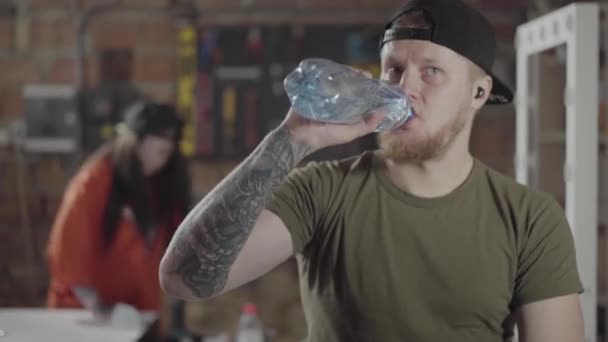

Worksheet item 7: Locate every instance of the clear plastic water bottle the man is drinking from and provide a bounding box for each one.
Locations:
[284,58,412,131]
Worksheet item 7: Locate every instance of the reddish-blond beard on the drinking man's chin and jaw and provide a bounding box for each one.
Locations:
[378,110,467,164]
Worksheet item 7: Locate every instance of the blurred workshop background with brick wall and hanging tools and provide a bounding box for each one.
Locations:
[0,0,607,341]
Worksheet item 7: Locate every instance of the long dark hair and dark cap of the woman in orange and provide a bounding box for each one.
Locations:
[102,103,191,246]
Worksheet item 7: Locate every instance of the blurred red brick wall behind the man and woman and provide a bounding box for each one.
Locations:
[0,0,522,341]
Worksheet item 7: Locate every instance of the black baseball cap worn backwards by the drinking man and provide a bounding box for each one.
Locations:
[380,0,513,104]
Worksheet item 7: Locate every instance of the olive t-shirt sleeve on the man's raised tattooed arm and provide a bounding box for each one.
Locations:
[266,162,338,254]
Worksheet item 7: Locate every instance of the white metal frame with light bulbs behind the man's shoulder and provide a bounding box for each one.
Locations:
[515,3,599,342]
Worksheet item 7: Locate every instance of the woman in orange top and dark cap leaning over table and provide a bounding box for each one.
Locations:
[47,102,190,310]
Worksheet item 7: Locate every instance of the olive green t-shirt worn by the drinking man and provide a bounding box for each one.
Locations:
[267,152,582,342]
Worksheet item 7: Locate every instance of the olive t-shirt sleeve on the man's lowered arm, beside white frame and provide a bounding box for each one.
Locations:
[513,197,582,307]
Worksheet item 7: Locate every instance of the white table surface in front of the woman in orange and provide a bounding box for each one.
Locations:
[0,308,148,342]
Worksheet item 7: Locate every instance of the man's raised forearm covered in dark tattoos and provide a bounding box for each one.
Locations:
[161,127,312,298]
